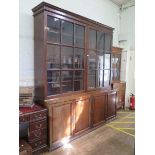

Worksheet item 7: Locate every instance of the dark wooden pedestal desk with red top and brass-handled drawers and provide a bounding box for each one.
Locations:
[19,105,48,154]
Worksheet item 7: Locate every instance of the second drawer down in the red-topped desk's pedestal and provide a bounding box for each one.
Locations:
[29,120,47,132]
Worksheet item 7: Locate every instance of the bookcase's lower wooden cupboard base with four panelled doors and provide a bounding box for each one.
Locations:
[44,90,117,150]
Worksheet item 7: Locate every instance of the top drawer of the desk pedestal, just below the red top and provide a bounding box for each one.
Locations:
[30,111,47,122]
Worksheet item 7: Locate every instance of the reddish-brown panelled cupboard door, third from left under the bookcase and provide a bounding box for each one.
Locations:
[93,93,106,126]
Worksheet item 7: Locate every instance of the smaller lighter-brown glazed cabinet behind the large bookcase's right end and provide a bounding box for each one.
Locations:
[112,47,126,109]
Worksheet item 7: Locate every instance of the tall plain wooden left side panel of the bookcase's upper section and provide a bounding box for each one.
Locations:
[34,13,45,100]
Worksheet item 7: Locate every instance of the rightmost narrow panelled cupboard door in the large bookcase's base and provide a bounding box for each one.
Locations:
[107,92,117,119]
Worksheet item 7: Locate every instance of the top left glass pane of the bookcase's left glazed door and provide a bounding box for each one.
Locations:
[47,16,60,43]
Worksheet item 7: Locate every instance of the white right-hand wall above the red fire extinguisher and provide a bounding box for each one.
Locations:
[119,4,135,106]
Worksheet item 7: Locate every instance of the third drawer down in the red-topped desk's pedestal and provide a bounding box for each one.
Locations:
[29,128,47,141]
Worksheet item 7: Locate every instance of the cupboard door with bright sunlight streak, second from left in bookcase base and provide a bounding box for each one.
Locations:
[74,98,91,134]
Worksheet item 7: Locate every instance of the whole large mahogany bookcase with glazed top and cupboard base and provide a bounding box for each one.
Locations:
[32,2,117,150]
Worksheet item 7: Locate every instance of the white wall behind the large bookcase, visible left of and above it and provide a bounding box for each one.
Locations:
[19,0,120,86]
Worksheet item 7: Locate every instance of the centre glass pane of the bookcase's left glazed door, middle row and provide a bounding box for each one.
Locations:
[61,46,73,68]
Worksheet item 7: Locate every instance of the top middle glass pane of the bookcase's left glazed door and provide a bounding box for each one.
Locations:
[62,21,73,45]
